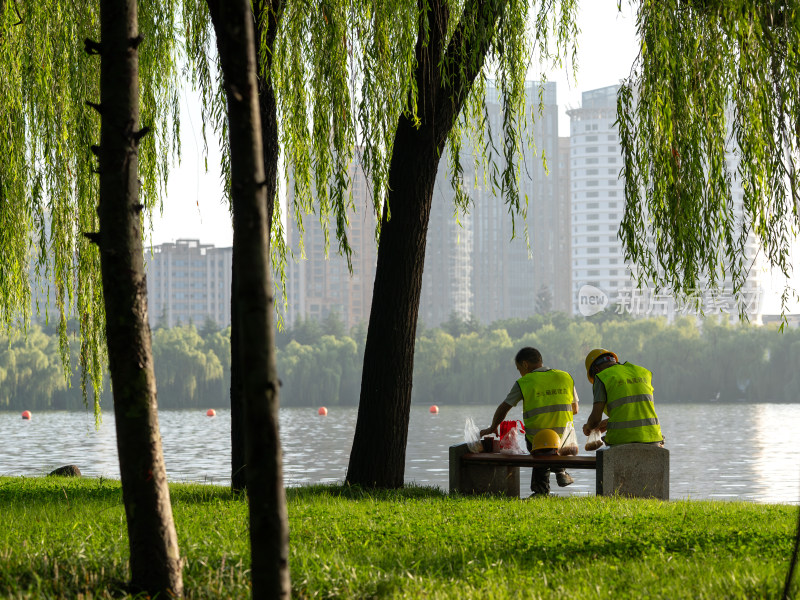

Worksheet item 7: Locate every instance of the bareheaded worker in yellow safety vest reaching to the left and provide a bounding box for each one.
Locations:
[481,347,578,495]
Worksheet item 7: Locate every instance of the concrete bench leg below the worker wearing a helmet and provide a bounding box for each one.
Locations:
[596,444,669,500]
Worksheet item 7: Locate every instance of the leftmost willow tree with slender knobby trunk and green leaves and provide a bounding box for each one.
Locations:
[0,1,182,594]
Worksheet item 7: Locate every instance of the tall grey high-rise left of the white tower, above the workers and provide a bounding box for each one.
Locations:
[470,81,570,323]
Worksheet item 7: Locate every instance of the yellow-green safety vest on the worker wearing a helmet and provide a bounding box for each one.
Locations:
[595,363,663,446]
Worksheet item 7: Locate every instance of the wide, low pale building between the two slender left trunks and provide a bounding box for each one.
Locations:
[145,240,233,328]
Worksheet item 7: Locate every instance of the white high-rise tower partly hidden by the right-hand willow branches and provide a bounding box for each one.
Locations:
[568,85,765,323]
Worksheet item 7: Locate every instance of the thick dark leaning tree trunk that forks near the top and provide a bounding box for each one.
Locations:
[347,0,506,488]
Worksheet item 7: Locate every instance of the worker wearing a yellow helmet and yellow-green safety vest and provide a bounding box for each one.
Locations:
[583,348,664,446]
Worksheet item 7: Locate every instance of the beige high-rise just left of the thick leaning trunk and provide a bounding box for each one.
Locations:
[286,150,377,328]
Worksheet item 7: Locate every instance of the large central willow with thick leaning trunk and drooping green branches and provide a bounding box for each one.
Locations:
[188,0,576,485]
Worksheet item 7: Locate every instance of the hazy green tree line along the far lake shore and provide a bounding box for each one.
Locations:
[0,313,800,410]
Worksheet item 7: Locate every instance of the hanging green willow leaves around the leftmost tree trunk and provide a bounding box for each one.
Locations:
[0,0,179,407]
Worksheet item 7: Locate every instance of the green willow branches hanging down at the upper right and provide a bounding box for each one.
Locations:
[617,0,800,597]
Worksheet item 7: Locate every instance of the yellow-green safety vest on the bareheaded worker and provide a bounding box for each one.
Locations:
[517,369,574,443]
